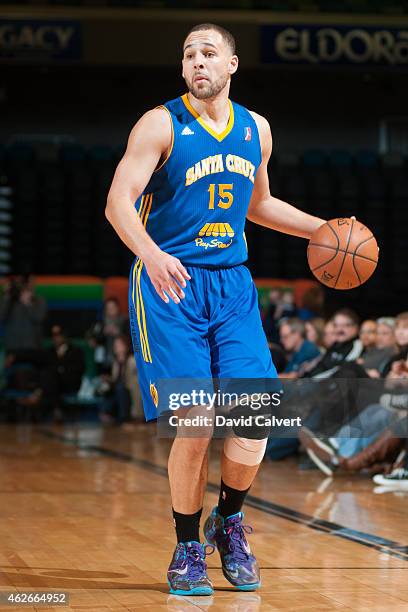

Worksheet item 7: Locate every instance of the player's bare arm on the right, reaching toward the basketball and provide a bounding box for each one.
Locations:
[247,113,325,239]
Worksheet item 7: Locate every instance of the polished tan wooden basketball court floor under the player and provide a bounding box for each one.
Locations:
[0,424,408,612]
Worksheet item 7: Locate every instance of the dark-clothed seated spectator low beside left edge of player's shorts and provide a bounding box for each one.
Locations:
[101,335,133,425]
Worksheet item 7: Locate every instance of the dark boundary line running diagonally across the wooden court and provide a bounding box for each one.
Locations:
[38,429,408,569]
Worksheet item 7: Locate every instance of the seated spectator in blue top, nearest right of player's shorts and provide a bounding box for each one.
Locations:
[279,317,320,378]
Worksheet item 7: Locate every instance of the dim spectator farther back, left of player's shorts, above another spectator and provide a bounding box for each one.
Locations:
[86,297,129,373]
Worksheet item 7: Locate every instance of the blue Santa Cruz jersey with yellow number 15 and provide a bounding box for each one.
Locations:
[135,94,262,267]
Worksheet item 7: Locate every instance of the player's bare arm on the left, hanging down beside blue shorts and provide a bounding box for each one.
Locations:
[105,108,190,303]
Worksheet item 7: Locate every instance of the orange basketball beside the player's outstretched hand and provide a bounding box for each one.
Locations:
[307,218,378,289]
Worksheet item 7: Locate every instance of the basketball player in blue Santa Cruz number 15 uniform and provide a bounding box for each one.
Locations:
[106,24,324,595]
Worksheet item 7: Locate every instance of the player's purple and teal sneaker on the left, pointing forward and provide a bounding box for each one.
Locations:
[167,541,214,595]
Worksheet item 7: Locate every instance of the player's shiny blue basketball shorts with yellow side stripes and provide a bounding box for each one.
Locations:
[129,258,277,421]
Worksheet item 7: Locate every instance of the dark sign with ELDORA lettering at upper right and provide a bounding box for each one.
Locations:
[261,25,408,66]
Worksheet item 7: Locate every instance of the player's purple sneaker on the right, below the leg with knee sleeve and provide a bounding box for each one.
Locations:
[204,507,261,591]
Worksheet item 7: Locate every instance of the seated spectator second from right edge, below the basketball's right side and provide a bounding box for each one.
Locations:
[357,317,397,378]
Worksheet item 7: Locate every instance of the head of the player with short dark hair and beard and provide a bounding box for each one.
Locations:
[182,23,238,100]
